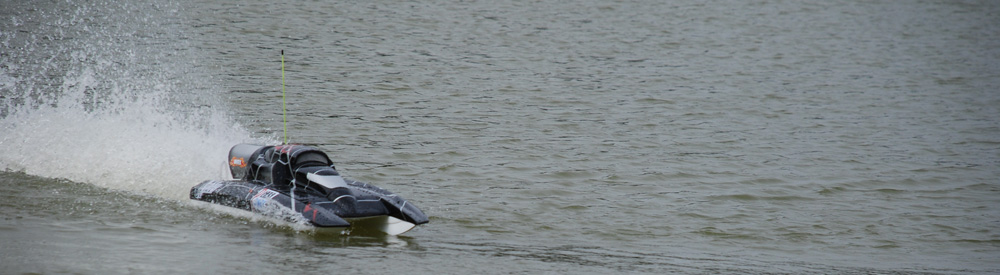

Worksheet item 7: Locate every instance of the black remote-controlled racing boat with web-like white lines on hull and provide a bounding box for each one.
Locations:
[191,144,428,235]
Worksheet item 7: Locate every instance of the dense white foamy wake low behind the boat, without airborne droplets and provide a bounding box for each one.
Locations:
[0,97,248,199]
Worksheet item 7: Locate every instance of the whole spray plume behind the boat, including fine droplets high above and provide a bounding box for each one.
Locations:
[0,1,264,200]
